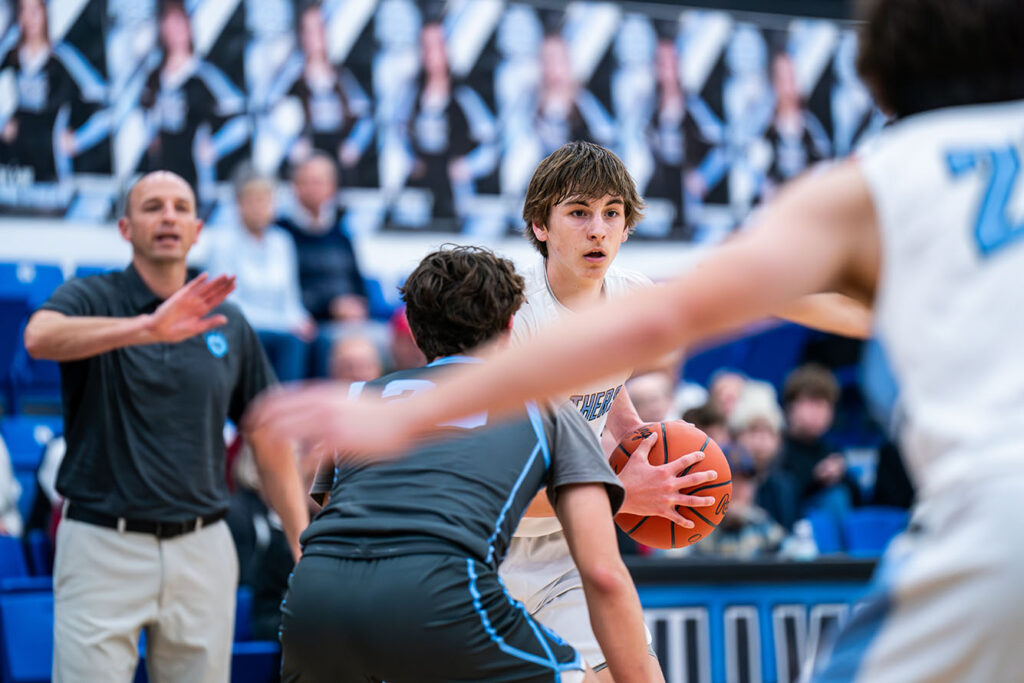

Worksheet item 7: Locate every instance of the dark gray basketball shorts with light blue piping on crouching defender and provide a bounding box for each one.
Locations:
[281,554,586,683]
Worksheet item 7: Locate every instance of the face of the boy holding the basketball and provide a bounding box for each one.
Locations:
[534,195,629,280]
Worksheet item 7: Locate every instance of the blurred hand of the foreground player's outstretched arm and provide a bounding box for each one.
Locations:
[243,382,412,461]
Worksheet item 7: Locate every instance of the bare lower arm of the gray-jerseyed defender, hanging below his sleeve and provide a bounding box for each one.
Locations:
[557,483,663,683]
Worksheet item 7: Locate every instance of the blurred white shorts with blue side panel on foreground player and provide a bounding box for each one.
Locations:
[813,473,1024,683]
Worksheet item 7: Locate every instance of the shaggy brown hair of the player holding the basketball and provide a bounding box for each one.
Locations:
[522,141,644,258]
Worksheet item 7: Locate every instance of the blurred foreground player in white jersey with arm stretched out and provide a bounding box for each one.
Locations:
[256,0,1024,683]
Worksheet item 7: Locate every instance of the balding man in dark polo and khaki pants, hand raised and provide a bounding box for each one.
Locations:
[25,171,308,683]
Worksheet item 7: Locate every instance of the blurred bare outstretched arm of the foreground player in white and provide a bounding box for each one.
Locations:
[243,162,880,453]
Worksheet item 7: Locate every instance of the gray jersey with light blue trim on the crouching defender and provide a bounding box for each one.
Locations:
[302,357,624,566]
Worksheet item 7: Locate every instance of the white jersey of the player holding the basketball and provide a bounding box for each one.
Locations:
[512,260,651,536]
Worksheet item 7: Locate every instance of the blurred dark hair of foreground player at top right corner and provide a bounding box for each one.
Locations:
[857,0,1024,117]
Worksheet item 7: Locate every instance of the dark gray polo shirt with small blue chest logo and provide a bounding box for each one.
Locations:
[40,266,275,522]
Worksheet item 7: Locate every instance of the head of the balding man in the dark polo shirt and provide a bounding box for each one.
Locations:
[118,171,203,264]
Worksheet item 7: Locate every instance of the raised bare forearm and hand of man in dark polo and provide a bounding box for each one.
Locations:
[25,273,234,360]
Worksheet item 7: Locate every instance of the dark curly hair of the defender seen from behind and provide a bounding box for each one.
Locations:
[400,245,524,360]
